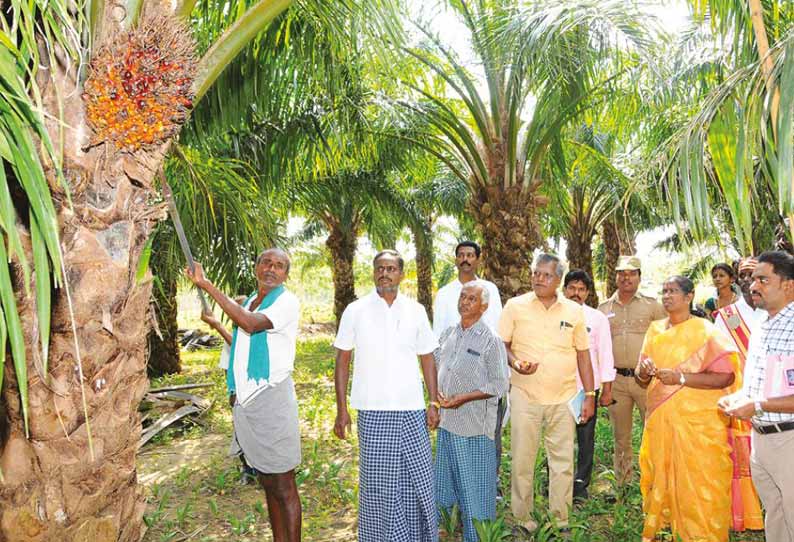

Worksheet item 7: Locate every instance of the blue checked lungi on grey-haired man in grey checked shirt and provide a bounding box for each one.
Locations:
[436,428,496,542]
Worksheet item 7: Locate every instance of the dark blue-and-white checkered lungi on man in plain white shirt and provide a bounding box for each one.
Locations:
[358,410,438,542]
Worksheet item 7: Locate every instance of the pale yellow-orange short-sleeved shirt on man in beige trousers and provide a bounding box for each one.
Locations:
[499,292,589,405]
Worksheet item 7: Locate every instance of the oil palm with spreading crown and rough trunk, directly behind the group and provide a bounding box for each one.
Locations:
[404,0,648,298]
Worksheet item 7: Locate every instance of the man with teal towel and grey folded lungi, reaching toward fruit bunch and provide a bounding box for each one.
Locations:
[185,248,301,542]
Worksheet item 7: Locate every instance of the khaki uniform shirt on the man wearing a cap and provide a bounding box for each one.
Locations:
[598,292,667,369]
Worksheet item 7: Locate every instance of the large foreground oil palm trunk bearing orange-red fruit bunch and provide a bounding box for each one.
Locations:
[0,0,400,541]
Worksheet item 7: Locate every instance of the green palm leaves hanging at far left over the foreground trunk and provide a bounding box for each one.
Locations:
[0,0,83,438]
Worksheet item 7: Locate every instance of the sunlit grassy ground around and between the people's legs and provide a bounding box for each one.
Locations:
[139,336,764,542]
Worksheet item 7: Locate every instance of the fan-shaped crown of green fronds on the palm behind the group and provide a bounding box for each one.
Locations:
[402,0,654,196]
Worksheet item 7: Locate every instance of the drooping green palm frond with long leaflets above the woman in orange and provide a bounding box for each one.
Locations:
[659,25,794,251]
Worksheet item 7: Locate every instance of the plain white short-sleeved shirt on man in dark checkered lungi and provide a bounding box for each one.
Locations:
[334,291,438,410]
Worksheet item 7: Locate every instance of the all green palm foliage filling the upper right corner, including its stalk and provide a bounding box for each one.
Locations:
[659,0,794,253]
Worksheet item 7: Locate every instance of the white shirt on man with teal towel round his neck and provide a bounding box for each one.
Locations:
[234,290,300,404]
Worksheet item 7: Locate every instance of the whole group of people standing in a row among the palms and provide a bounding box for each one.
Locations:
[187,241,794,542]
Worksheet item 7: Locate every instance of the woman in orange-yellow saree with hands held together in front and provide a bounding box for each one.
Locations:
[636,276,741,542]
